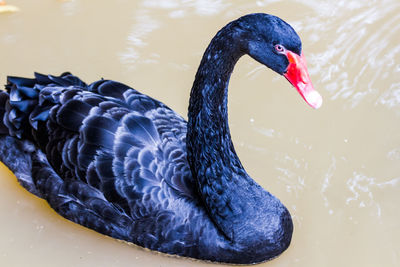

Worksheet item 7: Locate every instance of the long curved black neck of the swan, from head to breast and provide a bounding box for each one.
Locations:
[187,25,249,240]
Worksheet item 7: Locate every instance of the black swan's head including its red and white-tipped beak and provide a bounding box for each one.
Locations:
[236,13,322,109]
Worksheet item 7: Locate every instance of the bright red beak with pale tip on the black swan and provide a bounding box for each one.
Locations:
[283,51,322,109]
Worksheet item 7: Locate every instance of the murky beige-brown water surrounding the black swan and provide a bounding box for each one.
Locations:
[0,0,400,267]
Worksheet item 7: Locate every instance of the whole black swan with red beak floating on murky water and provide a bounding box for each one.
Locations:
[0,14,322,264]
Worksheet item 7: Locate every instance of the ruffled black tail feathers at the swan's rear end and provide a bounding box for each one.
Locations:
[0,72,87,197]
